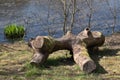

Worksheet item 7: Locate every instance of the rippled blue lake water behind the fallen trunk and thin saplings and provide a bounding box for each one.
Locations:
[0,0,120,42]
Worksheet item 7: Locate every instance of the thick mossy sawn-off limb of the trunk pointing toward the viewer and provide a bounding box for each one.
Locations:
[73,45,96,73]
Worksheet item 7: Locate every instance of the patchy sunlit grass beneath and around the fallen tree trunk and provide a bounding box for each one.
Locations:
[0,33,120,80]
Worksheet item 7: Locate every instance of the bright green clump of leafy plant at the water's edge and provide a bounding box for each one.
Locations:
[4,24,25,39]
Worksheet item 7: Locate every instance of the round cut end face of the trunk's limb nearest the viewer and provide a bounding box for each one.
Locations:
[82,60,96,73]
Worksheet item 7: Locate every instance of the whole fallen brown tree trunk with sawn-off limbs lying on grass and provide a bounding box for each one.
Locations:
[29,28,105,73]
